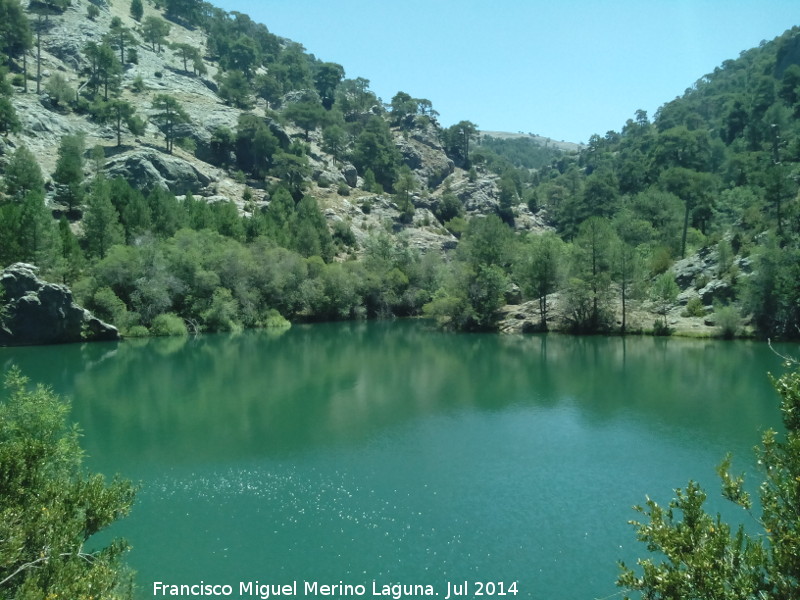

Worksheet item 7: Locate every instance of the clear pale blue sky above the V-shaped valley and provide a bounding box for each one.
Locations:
[211,0,800,143]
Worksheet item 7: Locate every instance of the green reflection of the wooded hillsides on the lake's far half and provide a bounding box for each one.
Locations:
[0,322,781,468]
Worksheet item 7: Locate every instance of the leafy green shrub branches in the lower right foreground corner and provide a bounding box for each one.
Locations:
[617,371,800,600]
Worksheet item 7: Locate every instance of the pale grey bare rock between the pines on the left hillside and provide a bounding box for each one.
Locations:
[0,0,556,255]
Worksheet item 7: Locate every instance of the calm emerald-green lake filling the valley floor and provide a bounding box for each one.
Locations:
[0,321,795,600]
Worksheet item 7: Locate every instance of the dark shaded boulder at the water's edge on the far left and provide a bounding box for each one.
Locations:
[0,263,119,346]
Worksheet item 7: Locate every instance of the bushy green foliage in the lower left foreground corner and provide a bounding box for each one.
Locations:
[0,368,135,598]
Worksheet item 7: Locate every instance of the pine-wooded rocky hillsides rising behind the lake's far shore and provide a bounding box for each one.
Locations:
[0,0,800,338]
